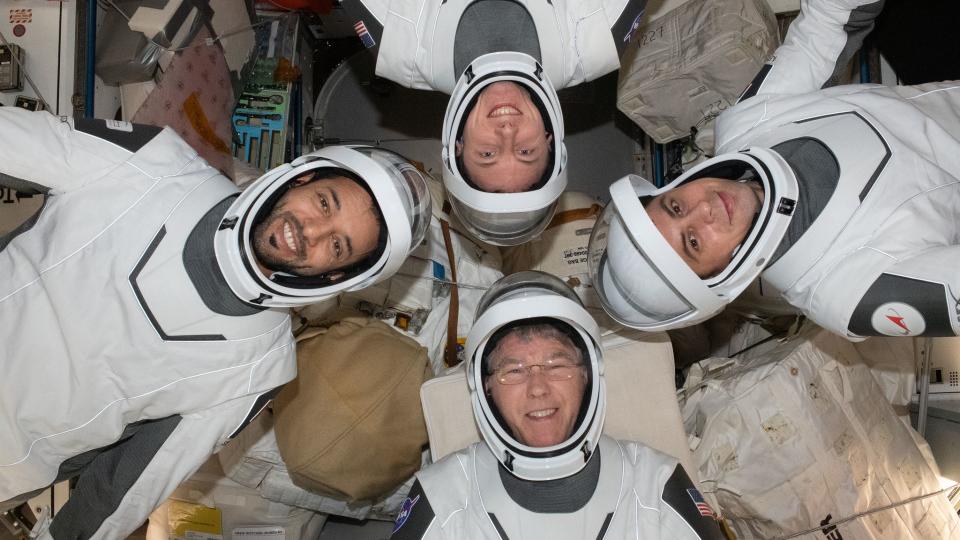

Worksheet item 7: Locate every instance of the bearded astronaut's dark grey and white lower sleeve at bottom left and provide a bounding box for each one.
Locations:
[37,394,269,538]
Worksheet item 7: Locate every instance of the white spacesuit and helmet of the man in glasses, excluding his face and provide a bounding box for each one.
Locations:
[392,272,722,539]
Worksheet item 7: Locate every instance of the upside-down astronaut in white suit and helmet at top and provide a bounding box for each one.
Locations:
[356,0,646,245]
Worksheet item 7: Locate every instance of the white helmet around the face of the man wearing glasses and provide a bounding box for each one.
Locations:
[466,271,606,481]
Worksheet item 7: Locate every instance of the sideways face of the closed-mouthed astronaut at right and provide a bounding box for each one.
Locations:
[646,177,763,278]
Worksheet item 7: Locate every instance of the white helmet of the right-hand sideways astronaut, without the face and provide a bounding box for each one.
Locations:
[588,148,798,331]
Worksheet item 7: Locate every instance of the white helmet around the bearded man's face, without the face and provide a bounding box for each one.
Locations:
[214,146,431,307]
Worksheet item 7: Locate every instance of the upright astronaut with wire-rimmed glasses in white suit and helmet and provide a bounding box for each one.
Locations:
[392,271,722,539]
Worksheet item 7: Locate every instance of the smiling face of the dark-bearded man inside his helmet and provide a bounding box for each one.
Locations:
[253,173,380,279]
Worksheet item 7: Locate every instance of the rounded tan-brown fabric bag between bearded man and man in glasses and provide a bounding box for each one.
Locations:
[274,316,429,501]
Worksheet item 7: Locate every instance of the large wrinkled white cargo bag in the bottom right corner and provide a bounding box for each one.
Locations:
[683,326,960,540]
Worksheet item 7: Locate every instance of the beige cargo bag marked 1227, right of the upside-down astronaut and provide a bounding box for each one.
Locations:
[617,0,779,143]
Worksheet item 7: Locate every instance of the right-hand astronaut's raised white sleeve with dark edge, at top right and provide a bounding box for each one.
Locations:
[741,0,884,100]
